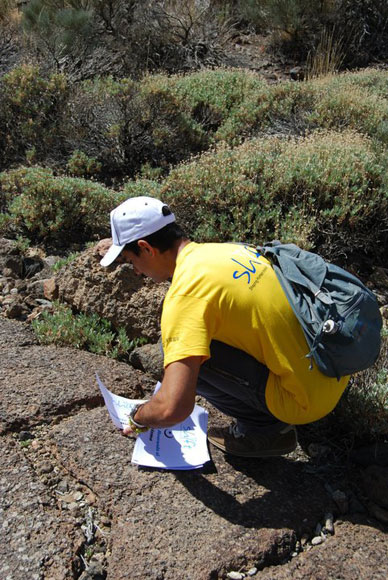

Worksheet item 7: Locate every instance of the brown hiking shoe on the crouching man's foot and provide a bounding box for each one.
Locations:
[208,424,297,457]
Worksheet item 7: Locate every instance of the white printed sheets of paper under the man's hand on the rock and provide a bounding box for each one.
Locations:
[96,373,210,469]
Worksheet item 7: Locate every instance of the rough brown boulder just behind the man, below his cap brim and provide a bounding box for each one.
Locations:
[54,247,168,342]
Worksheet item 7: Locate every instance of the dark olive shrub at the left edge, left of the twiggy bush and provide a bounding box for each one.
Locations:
[0,65,67,167]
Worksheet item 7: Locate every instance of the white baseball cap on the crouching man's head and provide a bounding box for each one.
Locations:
[100,196,175,266]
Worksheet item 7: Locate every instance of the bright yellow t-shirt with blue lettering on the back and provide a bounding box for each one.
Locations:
[161,242,349,424]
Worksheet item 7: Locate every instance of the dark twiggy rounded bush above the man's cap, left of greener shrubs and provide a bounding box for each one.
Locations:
[64,77,207,176]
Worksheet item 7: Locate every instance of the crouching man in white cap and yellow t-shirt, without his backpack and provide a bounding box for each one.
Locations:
[101,197,348,457]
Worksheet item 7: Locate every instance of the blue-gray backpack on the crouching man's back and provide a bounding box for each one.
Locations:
[257,241,382,380]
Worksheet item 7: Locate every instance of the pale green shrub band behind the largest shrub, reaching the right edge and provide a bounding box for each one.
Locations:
[153,70,388,147]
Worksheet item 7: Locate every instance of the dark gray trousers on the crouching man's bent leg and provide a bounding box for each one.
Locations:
[197,340,286,434]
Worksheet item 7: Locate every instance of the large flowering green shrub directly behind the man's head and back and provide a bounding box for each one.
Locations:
[160,132,388,262]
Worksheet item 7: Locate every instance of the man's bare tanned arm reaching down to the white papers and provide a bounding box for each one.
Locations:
[124,356,203,435]
